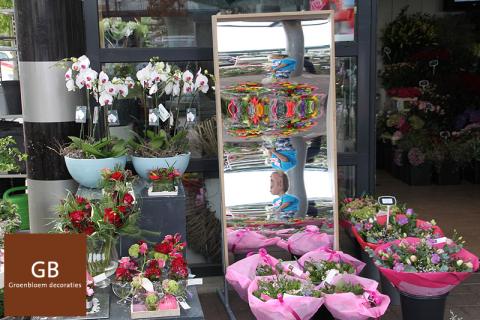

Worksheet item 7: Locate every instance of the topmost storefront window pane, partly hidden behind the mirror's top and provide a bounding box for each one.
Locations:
[98,0,355,48]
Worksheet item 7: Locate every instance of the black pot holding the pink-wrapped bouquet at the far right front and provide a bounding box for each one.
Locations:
[400,292,448,320]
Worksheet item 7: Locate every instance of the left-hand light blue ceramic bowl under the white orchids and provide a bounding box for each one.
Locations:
[65,156,127,188]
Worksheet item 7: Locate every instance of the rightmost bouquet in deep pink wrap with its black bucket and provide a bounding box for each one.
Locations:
[367,235,479,319]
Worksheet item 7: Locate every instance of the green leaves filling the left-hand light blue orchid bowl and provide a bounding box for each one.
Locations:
[61,136,127,159]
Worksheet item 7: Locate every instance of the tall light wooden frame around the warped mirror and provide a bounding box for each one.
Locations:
[212,10,339,271]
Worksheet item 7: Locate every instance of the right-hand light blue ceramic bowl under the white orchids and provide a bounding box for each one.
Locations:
[132,152,190,180]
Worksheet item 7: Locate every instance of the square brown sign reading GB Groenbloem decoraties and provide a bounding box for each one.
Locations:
[5,234,87,316]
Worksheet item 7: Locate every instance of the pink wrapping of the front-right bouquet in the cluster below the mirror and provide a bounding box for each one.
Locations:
[325,274,390,320]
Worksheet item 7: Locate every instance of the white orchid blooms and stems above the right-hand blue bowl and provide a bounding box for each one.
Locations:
[129,58,210,158]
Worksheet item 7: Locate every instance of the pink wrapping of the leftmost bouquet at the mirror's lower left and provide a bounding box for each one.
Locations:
[225,249,278,301]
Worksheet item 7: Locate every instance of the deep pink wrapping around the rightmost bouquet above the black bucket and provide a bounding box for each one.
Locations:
[375,238,479,297]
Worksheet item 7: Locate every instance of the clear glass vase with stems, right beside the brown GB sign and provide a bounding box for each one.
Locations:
[87,236,118,288]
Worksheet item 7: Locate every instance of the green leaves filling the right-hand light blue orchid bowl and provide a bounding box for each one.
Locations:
[128,130,188,158]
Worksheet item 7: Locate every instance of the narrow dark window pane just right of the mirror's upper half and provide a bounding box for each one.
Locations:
[335,57,358,152]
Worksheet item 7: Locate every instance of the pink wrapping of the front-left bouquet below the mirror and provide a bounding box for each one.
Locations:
[248,277,323,320]
